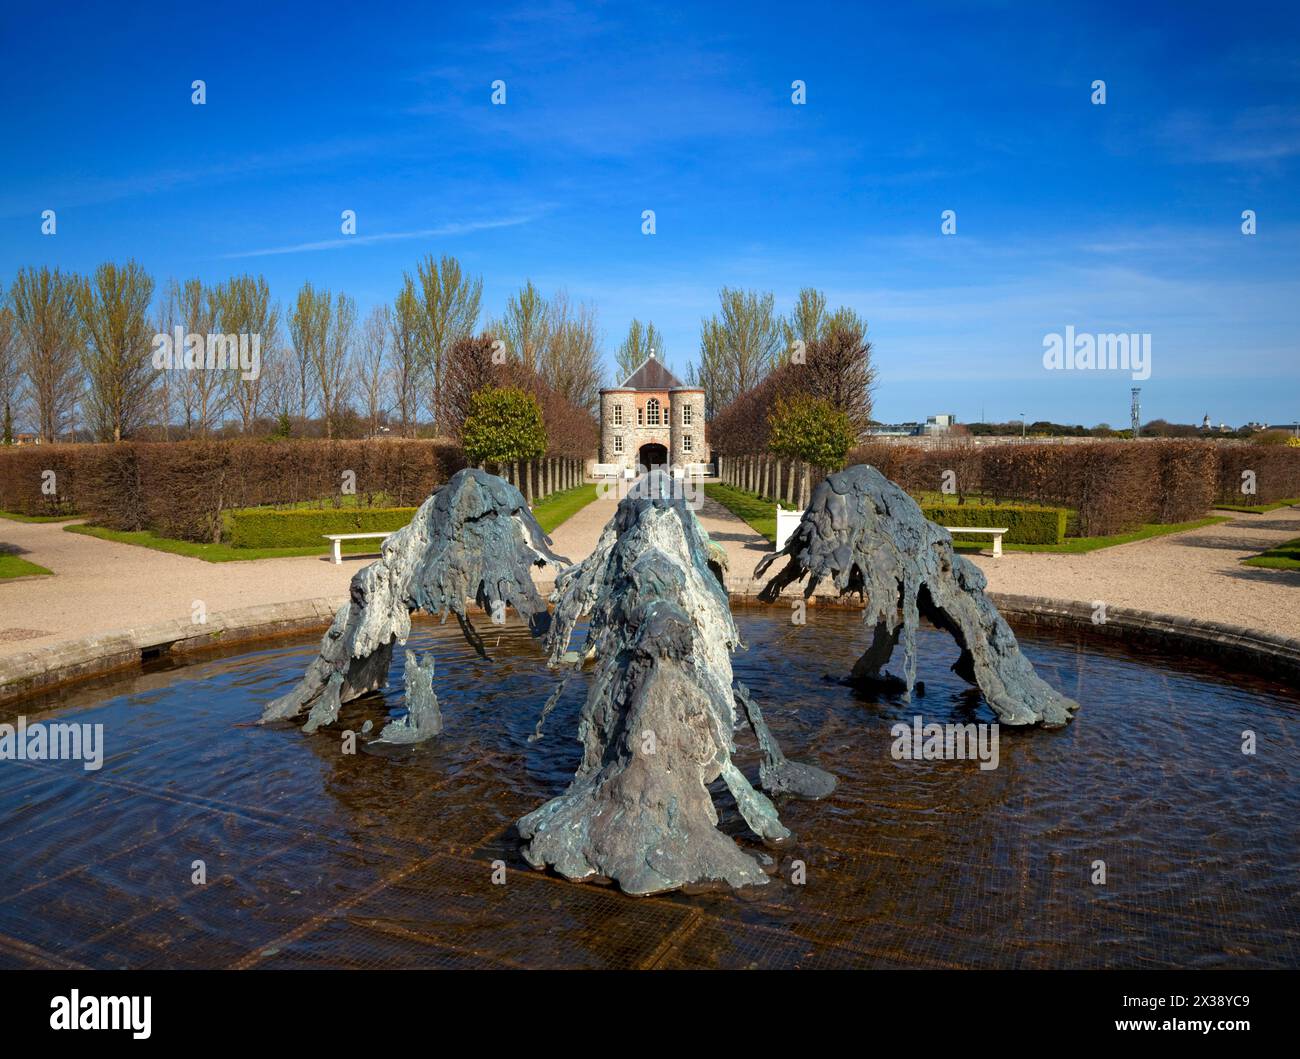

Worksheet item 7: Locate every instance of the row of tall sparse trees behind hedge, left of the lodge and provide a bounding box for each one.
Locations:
[0,255,603,443]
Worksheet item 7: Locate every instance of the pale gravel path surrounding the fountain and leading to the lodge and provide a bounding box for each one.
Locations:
[0,498,1300,656]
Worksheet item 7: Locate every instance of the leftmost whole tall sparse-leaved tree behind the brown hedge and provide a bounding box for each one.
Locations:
[10,268,82,442]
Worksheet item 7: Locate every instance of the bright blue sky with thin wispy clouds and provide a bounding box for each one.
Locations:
[0,3,1300,425]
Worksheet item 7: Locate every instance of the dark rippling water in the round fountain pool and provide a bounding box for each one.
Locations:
[0,609,1300,967]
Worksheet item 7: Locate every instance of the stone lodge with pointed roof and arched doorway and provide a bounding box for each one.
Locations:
[601,352,709,468]
